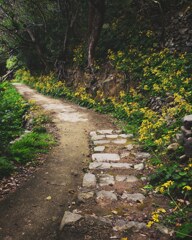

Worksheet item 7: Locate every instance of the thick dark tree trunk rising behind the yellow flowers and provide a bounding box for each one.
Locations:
[88,0,105,68]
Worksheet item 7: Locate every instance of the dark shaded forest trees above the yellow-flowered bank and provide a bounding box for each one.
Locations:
[0,0,192,78]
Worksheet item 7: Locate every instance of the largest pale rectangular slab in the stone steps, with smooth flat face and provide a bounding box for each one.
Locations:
[92,153,120,162]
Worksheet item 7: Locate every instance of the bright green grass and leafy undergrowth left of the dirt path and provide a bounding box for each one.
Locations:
[0,82,54,178]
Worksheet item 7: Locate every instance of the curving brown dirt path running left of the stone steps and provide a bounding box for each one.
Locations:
[0,84,114,240]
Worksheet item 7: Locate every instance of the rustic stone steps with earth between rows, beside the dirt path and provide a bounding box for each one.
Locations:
[61,129,170,240]
